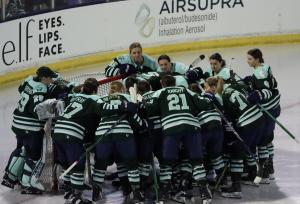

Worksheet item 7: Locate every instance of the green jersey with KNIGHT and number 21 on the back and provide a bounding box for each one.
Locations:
[145,87,211,135]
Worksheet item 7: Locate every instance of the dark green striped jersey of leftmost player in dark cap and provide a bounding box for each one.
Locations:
[12,76,48,135]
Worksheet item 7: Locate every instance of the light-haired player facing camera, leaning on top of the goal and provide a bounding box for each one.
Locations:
[105,42,159,77]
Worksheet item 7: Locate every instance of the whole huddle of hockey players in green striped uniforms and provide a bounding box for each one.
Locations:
[2,43,280,203]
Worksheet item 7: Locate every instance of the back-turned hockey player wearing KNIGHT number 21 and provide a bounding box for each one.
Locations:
[146,75,212,204]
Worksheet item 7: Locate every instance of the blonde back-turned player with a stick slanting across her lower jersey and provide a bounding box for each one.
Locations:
[93,81,147,203]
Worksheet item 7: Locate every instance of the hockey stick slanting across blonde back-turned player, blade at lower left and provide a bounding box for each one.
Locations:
[59,113,127,179]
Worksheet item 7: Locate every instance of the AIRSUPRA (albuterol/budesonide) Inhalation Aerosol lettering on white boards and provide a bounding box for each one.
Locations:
[158,0,245,37]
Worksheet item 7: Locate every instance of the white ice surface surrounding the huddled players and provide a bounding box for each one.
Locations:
[0,44,300,204]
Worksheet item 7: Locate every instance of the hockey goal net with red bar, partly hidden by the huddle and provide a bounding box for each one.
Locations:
[40,72,122,193]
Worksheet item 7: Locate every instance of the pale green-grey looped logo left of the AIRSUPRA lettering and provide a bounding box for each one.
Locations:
[135,4,155,38]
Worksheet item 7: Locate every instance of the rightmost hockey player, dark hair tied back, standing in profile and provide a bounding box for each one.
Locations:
[244,48,280,183]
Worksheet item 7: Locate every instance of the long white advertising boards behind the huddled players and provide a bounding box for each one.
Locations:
[0,0,300,75]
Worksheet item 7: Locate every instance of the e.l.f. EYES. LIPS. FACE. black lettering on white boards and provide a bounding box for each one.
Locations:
[0,16,65,66]
